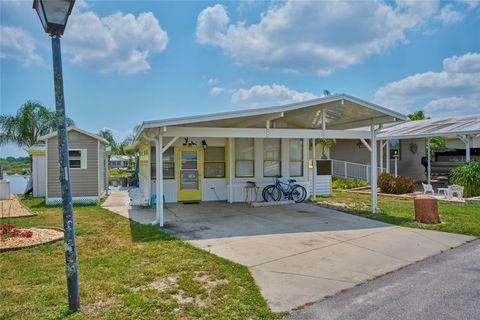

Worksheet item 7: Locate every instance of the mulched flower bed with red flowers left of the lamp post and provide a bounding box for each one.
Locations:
[0,224,63,252]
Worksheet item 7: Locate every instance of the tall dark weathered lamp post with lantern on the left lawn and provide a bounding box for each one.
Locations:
[33,0,80,312]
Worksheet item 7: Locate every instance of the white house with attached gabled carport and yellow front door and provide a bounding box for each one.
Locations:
[135,94,407,226]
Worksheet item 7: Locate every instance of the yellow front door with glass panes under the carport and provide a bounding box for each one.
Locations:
[177,147,202,201]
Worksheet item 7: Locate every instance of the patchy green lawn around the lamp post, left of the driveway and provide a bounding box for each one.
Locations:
[0,198,280,319]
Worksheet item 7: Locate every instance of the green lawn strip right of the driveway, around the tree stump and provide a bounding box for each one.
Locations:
[317,191,480,237]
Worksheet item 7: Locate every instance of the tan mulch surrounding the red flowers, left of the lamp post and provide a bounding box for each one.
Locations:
[0,227,63,253]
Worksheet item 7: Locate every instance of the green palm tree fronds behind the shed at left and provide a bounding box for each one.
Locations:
[0,101,75,161]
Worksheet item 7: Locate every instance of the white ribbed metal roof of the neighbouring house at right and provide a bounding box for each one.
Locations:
[377,115,480,140]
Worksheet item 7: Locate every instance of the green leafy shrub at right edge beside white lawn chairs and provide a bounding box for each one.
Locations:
[449,161,480,198]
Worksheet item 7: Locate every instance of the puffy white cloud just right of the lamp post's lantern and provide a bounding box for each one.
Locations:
[64,11,168,74]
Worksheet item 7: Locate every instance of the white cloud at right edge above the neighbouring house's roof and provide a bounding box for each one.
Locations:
[375,52,480,117]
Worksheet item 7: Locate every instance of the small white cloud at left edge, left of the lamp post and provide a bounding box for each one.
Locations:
[0,26,42,66]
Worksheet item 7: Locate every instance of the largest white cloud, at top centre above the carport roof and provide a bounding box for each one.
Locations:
[196,1,438,75]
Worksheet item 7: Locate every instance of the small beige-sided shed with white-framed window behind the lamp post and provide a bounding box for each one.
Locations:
[30,127,108,205]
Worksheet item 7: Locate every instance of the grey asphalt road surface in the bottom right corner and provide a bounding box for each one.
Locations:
[286,240,480,320]
